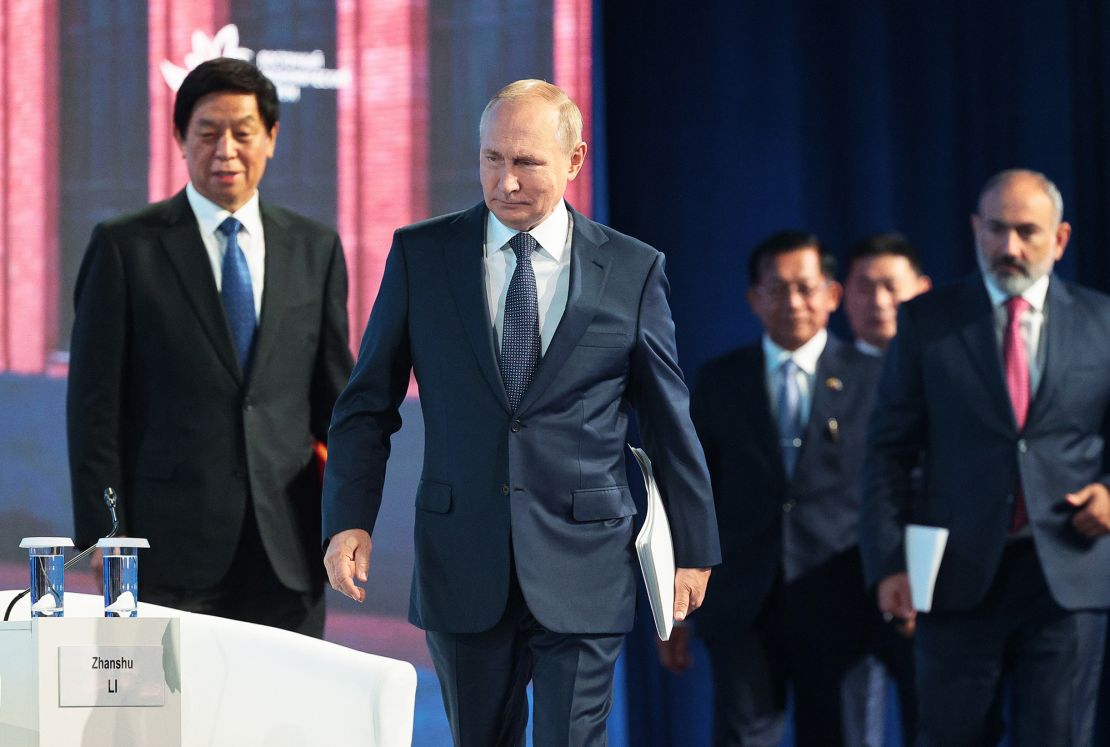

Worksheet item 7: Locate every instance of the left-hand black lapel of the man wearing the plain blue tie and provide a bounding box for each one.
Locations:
[161,191,242,382]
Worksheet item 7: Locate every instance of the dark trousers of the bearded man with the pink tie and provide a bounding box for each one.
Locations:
[916,539,1106,747]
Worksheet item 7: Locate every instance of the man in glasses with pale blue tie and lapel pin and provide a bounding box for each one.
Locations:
[664,231,879,747]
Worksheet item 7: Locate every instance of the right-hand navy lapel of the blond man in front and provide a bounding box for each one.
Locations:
[515,206,609,413]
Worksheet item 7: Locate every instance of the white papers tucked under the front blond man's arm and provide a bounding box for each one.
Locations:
[628,445,675,640]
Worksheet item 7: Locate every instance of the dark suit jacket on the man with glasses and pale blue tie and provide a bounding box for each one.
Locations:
[692,335,880,638]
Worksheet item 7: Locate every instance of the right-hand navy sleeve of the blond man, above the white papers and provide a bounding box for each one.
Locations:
[629,254,720,568]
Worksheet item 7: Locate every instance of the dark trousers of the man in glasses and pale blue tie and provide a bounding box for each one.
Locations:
[706,549,878,747]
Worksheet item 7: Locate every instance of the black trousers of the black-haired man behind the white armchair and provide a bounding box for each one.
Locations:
[139,505,324,638]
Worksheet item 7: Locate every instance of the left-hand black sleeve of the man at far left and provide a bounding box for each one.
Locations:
[65,226,129,547]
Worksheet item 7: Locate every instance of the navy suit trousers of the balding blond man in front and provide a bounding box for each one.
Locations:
[426,573,624,747]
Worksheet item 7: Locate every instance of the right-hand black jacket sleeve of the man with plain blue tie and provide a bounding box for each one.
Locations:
[311,236,353,444]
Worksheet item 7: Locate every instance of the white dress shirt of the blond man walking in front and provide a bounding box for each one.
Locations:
[484,200,574,354]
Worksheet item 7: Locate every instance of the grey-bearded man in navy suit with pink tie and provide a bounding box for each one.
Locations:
[861,170,1110,746]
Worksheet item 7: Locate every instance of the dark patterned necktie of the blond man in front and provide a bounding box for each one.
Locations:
[501,233,539,412]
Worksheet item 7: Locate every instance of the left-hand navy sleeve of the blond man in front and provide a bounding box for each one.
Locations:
[323,233,412,544]
